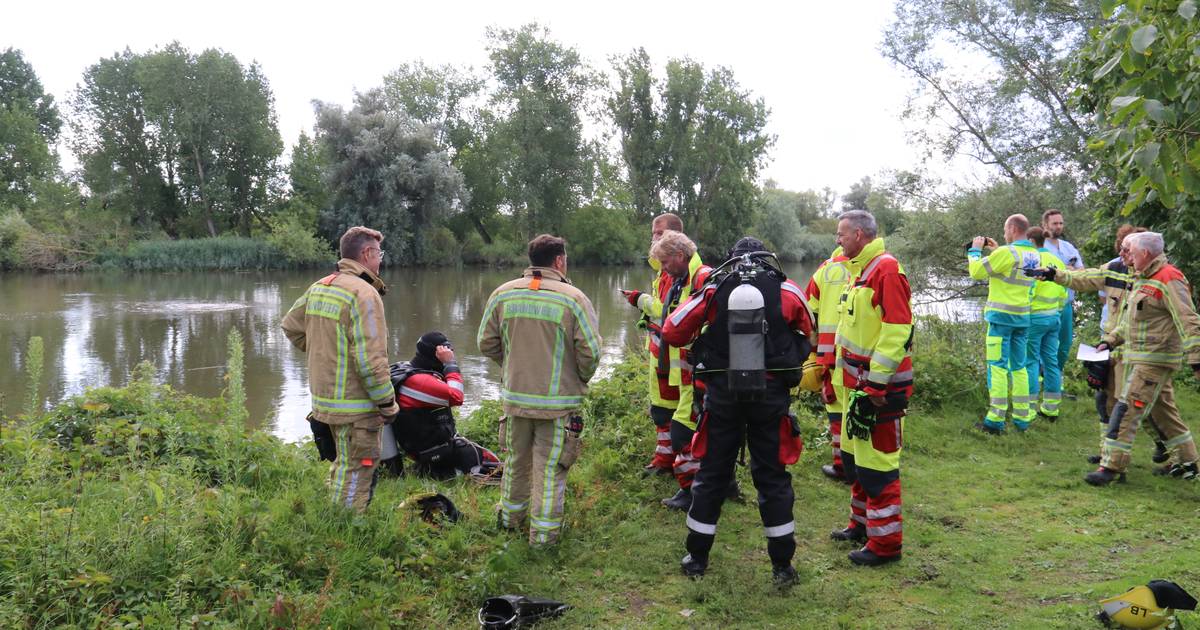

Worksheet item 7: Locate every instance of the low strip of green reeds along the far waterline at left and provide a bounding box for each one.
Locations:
[117,236,288,271]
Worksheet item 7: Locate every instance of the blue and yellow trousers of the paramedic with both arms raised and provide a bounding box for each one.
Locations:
[984,322,1033,430]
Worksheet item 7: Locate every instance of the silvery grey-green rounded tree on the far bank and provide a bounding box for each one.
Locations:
[316,89,464,264]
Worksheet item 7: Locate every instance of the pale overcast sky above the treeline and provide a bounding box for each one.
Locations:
[7,0,945,192]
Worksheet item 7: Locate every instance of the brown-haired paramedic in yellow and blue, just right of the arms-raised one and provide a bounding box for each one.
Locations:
[1025,226,1067,422]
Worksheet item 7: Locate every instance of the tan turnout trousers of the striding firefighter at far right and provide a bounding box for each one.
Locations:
[1100,364,1200,473]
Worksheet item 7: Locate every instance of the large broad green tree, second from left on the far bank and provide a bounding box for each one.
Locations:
[72,43,283,238]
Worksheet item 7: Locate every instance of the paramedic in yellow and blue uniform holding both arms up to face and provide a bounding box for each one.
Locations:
[967,215,1042,433]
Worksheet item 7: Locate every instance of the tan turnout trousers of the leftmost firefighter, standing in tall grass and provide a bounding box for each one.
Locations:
[328,418,382,514]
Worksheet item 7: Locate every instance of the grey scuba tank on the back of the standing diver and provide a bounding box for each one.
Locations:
[727,283,767,394]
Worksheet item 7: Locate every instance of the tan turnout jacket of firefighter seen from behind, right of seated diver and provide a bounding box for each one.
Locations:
[476,266,601,419]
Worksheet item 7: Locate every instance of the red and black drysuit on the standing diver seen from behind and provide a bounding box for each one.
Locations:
[662,269,812,566]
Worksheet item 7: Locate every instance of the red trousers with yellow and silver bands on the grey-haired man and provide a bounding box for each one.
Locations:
[841,396,907,557]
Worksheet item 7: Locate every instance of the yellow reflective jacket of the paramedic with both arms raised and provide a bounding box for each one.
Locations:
[967,240,1042,326]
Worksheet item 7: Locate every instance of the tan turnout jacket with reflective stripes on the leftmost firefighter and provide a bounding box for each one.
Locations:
[281,258,395,425]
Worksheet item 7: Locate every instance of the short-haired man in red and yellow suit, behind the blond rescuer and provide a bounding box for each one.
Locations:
[620,212,702,476]
